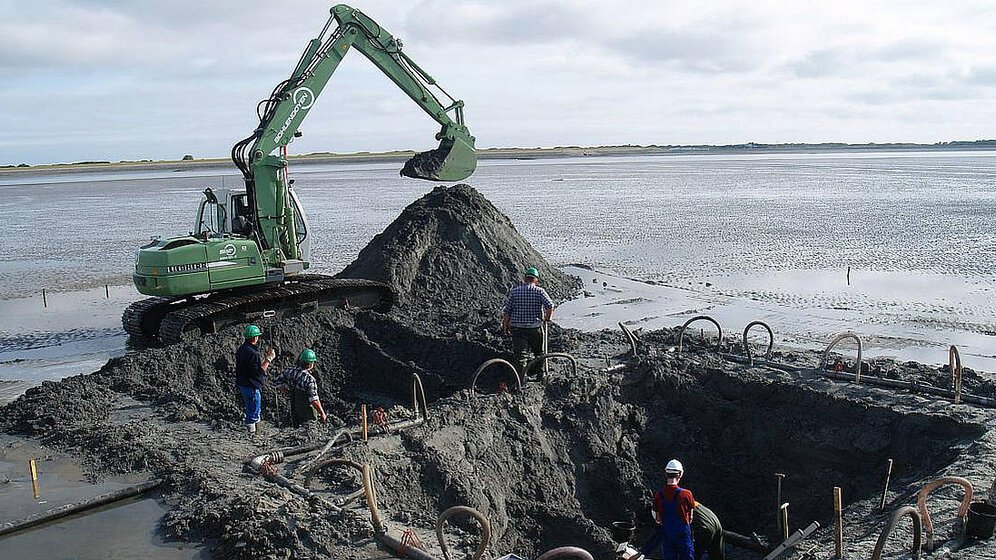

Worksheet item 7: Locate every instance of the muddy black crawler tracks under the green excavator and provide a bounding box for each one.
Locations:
[122,275,394,344]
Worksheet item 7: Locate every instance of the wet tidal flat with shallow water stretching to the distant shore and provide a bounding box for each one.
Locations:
[0,152,996,393]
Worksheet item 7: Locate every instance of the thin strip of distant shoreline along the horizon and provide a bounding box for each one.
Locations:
[0,140,996,176]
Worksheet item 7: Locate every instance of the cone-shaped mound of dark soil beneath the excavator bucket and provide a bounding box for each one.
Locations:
[339,184,580,322]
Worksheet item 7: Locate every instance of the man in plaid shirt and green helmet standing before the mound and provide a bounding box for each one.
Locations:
[501,268,553,375]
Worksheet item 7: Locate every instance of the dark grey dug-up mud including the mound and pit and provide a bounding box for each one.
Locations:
[0,186,996,559]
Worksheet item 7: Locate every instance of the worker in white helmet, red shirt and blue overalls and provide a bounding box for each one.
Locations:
[640,459,695,560]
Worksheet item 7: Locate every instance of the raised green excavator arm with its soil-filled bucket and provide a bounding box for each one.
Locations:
[232,4,477,264]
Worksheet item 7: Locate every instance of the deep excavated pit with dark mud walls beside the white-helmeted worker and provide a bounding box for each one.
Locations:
[356,359,985,556]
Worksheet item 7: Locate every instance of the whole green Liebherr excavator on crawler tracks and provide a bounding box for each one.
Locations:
[122,4,477,344]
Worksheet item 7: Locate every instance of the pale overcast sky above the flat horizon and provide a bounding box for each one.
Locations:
[0,0,996,164]
